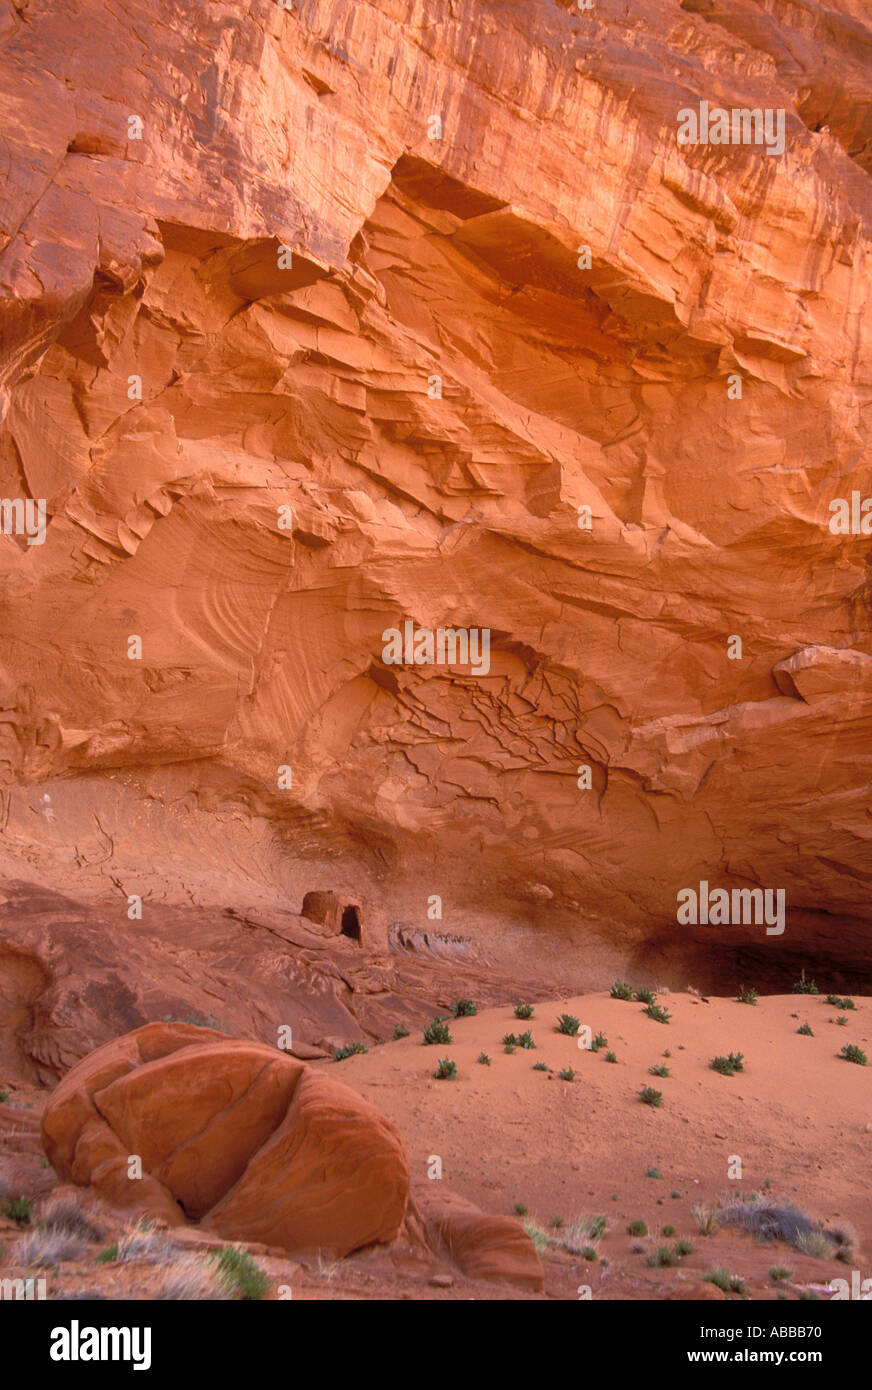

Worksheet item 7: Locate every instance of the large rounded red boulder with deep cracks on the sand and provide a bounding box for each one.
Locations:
[42,1024,409,1255]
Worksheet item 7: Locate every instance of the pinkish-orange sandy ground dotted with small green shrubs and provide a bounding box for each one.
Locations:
[0,992,872,1300]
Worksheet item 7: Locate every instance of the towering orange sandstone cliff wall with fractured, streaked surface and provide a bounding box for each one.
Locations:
[0,0,872,984]
